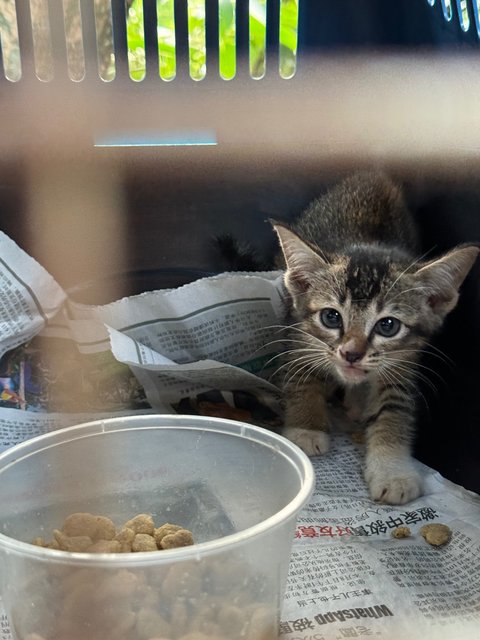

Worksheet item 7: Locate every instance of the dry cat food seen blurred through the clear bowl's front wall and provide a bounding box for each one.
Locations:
[15,552,278,640]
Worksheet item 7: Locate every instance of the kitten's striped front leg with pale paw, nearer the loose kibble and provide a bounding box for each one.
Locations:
[365,400,422,504]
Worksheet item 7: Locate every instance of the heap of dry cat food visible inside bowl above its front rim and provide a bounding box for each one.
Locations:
[33,513,194,553]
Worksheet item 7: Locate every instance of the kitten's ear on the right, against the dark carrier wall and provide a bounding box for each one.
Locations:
[415,245,480,316]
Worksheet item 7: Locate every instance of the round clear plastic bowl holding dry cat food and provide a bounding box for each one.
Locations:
[0,415,314,640]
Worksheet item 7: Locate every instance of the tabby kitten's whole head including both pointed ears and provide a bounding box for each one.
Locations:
[276,226,478,385]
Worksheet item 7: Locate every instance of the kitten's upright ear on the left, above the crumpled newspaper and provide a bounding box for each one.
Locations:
[272,222,329,295]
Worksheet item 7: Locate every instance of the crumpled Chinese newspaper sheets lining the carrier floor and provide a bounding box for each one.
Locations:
[0,232,480,640]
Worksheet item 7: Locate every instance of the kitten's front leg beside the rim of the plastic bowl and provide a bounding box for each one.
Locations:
[283,381,330,456]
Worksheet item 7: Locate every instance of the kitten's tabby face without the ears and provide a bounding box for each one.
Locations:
[293,258,432,385]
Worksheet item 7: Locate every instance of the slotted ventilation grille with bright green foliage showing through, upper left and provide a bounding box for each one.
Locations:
[0,0,300,82]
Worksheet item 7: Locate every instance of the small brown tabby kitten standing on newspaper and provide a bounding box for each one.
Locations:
[272,173,479,504]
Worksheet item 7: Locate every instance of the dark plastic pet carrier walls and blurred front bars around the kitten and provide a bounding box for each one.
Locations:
[0,0,480,492]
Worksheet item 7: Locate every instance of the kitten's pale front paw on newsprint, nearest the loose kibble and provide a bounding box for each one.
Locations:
[365,465,422,504]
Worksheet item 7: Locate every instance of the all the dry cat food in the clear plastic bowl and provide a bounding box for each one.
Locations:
[17,513,278,640]
